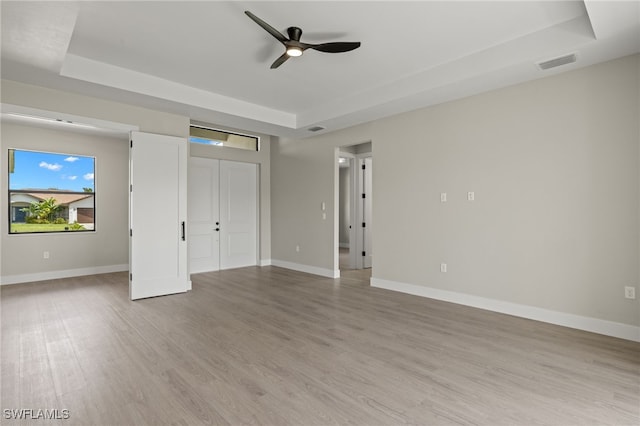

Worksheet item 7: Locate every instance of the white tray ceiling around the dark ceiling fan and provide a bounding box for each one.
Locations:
[1,0,640,137]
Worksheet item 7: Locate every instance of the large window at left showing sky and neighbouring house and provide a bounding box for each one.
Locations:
[8,149,95,234]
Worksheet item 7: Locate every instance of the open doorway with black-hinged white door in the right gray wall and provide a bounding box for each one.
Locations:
[335,142,373,270]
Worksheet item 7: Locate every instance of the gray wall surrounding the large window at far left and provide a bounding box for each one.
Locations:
[0,123,129,277]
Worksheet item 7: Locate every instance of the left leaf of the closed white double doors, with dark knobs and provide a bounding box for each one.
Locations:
[188,157,220,273]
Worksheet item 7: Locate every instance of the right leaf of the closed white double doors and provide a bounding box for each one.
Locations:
[220,161,258,269]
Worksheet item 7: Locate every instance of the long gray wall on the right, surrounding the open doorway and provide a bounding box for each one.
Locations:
[272,55,640,326]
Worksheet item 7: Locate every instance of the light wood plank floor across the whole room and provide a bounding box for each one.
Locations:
[0,267,640,425]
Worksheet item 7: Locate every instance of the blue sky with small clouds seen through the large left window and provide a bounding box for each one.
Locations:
[9,150,95,192]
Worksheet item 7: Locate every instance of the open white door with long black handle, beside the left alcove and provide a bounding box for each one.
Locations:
[129,132,191,300]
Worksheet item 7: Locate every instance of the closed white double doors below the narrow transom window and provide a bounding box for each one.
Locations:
[188,157,258,273]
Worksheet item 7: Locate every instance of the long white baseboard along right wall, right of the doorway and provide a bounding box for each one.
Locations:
[371,277,640,342]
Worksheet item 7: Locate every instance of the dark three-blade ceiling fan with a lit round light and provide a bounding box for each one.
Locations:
[244,10,360,69]
